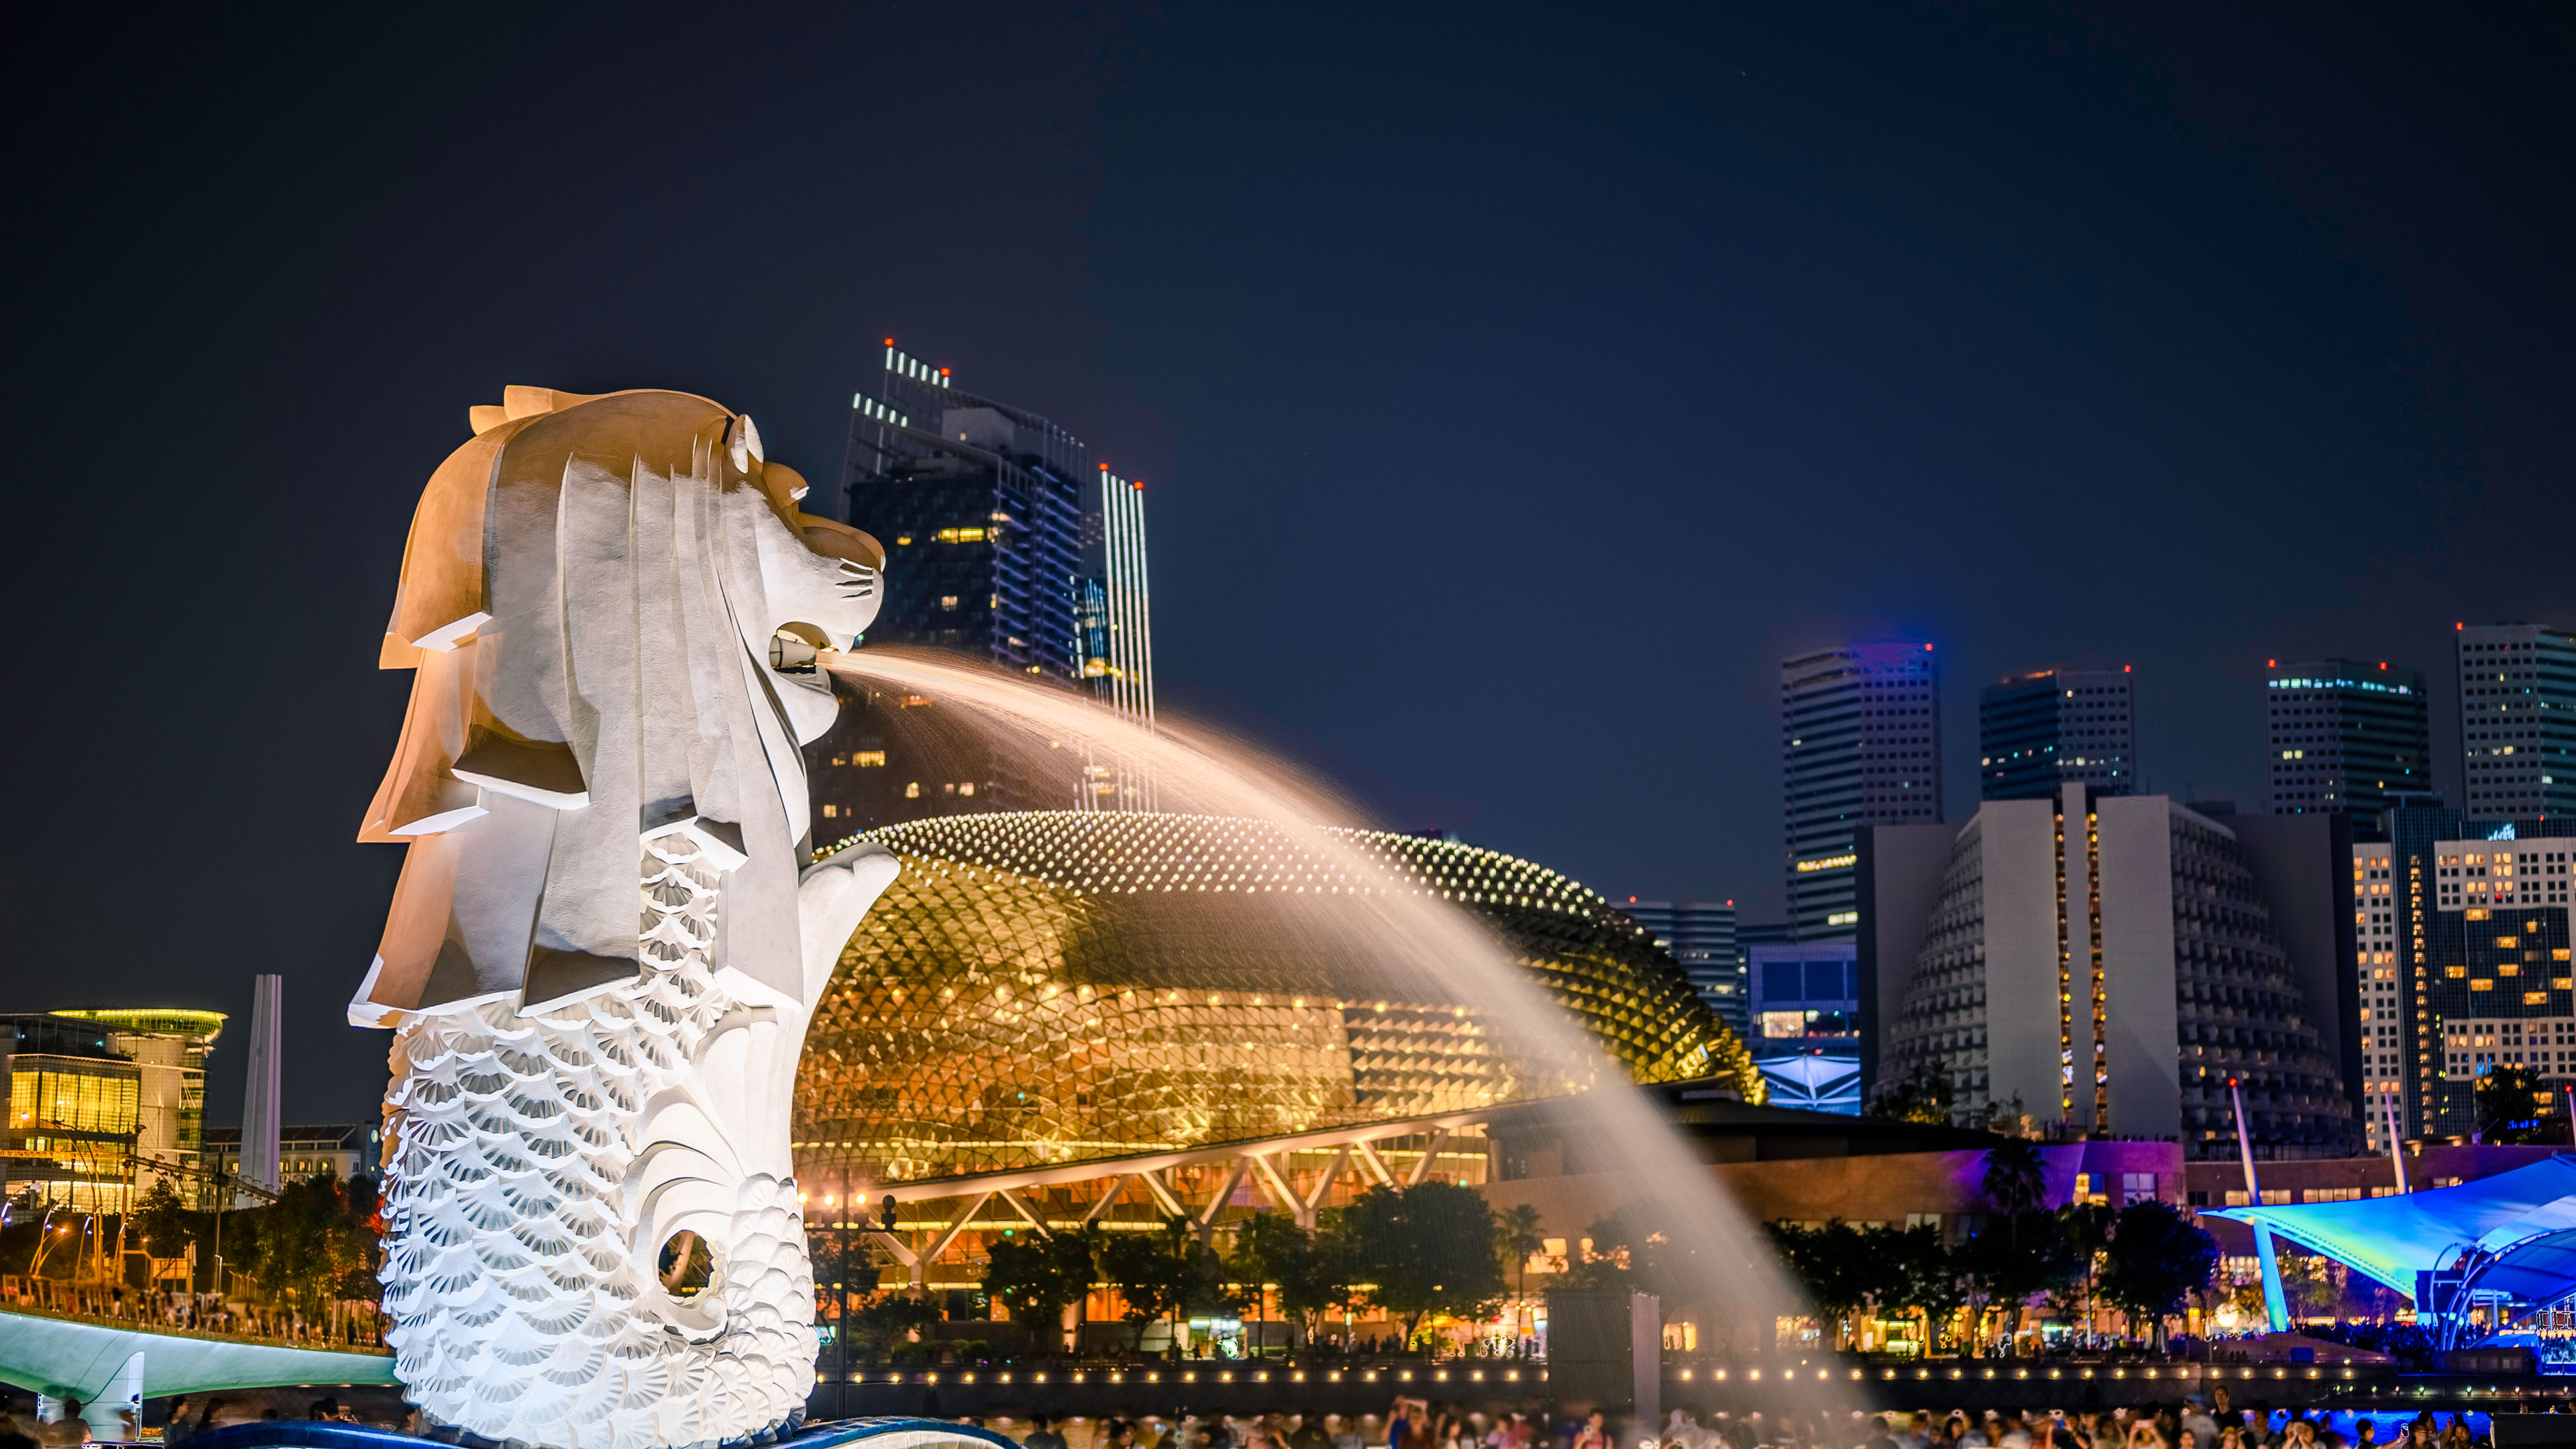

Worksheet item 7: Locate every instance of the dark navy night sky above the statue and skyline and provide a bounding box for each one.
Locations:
[0,5,2576,1122]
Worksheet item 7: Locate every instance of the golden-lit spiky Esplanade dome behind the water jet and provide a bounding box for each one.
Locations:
[796,812,1762,1181]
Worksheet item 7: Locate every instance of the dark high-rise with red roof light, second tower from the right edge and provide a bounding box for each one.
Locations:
[2264,660,2432,833]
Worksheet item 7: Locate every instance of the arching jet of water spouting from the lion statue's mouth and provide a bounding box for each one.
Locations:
[824,647,1865,1413]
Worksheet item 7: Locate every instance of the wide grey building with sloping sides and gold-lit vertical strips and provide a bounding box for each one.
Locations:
[1878,786,2359,1158]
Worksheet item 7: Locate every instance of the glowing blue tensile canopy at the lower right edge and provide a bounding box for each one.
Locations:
[2205,1152,2576,1284]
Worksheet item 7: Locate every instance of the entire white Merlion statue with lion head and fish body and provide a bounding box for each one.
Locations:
[350,387,896,1449]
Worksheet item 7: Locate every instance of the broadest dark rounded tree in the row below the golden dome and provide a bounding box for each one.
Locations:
[1334,1183,1507,1343]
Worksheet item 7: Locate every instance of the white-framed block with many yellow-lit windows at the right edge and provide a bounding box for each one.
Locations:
[2355,799,2576,1140]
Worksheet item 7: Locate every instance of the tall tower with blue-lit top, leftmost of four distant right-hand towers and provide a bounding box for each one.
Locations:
[1780,642,1942,941]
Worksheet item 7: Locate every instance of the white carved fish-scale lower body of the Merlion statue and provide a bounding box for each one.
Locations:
[381,835,816,1449]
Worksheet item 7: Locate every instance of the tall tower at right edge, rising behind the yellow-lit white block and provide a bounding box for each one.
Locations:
[2460,624,2576,820]
